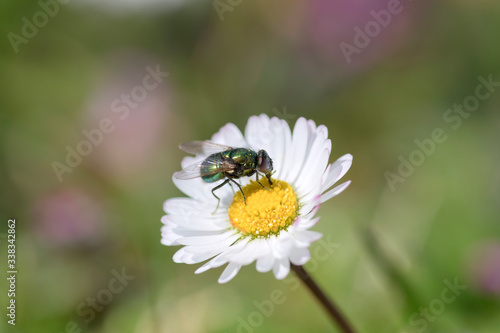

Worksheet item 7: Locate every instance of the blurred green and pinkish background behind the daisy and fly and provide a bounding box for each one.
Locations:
[0,0,500,333]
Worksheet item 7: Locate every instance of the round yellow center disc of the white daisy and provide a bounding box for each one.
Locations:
[228,178,299,237]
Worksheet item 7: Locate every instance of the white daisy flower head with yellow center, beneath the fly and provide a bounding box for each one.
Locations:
[161,115,352,283]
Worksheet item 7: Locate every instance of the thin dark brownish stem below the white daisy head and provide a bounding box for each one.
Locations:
[290,263,356,333]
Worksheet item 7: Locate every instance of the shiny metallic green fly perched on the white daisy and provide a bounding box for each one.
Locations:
[174,141,273,211]
